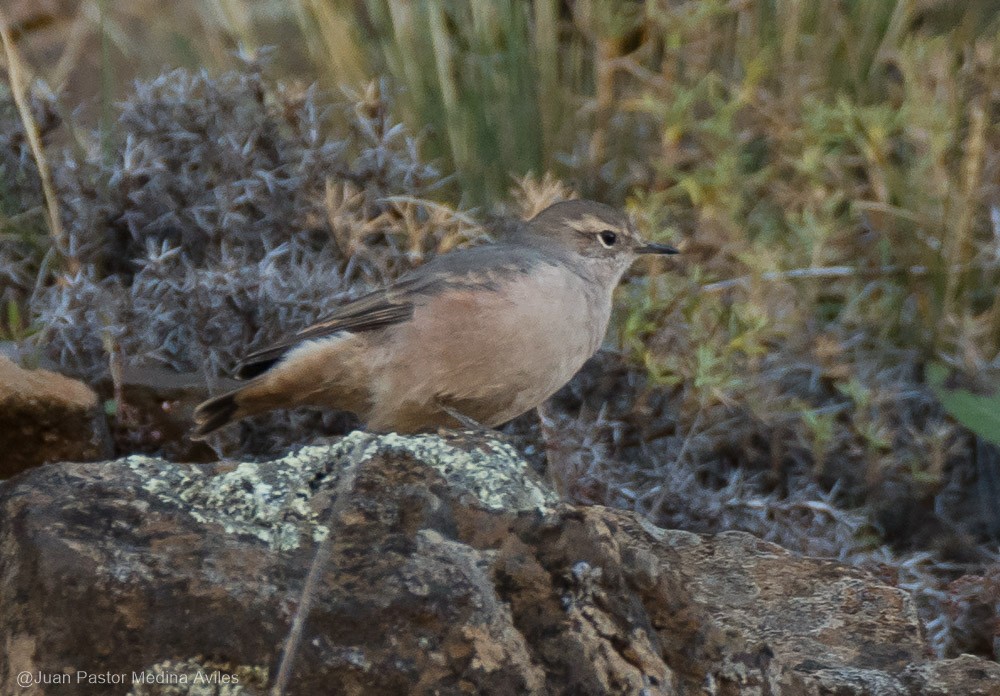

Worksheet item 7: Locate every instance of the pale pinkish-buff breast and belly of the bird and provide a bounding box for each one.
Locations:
[368,265,611,431]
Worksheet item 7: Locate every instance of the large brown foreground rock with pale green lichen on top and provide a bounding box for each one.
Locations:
[0,433,1000,696]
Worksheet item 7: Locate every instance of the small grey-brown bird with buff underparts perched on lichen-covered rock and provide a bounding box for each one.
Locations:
[192,200,678,440]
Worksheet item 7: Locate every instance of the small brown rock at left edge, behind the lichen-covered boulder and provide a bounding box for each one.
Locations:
[0,355,111,479]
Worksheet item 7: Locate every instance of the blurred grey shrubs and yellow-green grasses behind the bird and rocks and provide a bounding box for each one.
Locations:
[0,0,1000,657]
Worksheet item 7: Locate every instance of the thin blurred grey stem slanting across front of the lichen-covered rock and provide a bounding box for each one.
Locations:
[271,435,372,696]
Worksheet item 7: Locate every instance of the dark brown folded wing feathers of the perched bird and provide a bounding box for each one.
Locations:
[236,274,434,379]
